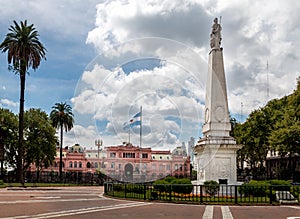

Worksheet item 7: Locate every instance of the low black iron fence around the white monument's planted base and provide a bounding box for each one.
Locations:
[104,182,300,204]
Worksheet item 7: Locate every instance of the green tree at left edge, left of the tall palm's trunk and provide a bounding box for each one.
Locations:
[0,108,18,179]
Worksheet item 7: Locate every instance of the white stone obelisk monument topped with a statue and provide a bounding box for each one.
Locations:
[194,18,240,184]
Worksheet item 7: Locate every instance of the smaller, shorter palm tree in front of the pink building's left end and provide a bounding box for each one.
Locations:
[50,102,74,180]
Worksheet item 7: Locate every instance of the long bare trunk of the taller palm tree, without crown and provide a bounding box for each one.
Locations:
[17,72,26,185]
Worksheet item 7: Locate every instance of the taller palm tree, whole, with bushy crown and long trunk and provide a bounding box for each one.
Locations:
[0,20,46,184]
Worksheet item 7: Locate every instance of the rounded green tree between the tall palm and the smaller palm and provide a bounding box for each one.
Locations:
[24,109,57,179]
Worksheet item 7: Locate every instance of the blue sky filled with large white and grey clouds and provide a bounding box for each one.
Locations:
[0,0,300,149]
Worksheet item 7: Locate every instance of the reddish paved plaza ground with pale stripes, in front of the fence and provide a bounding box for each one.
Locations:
[0,187,300,219]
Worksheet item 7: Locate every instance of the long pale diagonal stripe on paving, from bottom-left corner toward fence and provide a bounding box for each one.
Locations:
[1,202,152,219]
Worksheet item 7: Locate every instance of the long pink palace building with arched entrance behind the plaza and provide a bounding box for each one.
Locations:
[31,144,190,182]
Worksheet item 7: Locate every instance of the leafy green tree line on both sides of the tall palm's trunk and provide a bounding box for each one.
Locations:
[0,108,57,180]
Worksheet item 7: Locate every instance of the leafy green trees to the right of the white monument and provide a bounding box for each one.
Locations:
[233,78,300,178]
